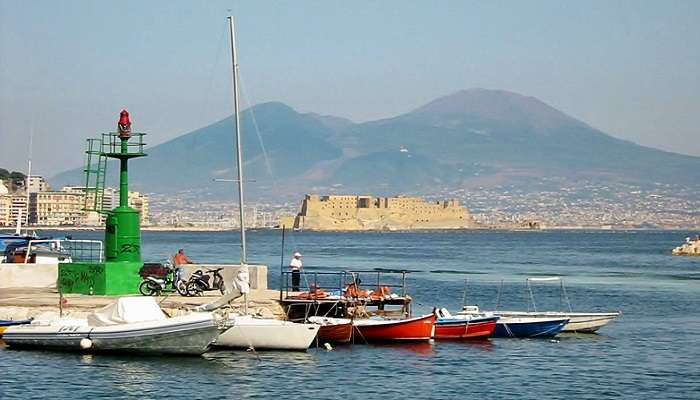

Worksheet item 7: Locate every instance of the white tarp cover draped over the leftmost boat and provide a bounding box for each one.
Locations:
[87,297,166,326]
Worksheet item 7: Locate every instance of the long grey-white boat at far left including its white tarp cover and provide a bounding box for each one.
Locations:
[3,297,220,355]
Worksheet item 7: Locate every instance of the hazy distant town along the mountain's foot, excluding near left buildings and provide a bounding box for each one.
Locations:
[145,179,700,229]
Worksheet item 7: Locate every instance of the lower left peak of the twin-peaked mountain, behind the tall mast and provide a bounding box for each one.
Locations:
[52,103,341,196]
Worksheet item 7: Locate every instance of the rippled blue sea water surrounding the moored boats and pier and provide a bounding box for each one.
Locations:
[0,231,700,399]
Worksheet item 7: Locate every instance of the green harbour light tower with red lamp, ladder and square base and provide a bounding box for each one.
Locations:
[58,110,146,295]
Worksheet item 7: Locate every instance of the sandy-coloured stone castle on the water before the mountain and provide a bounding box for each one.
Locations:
[280,195,476,231]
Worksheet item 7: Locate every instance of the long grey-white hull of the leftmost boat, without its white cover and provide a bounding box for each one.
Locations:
[3,315,219,355]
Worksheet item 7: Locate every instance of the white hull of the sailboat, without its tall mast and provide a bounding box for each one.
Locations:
[214,315,321,351]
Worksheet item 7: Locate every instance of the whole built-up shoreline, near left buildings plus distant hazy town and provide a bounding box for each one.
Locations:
[0,170,700,229]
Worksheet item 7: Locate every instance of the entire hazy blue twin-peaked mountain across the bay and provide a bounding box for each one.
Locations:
[53,89,700,199]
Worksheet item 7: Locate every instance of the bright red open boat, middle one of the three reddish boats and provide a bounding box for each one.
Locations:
[353,314,436,342]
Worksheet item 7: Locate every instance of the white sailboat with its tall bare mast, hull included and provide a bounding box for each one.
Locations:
[208,17,320,351]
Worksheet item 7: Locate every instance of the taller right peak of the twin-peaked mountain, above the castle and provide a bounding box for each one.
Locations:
[331,89,700,188]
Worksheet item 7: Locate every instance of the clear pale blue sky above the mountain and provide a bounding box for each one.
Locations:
[0,0,700,176]
